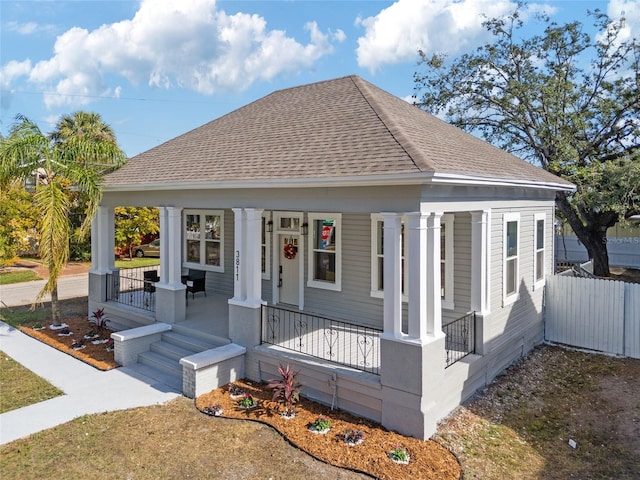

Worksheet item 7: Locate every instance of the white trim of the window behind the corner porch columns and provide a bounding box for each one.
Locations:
[370,213,455,310]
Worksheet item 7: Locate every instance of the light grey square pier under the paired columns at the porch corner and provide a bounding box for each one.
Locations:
[380,335,445,440]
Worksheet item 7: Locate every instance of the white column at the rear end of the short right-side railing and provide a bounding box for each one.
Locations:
[471,210,489,315]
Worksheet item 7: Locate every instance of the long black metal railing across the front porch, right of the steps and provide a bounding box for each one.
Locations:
[262,305,382,375]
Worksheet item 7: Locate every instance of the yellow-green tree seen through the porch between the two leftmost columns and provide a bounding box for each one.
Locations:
[115,207,160,260]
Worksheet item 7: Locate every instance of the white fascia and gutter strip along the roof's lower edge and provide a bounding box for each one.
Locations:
[103,173,576,193]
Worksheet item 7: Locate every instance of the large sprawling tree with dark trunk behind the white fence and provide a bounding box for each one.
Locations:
[415,11,640,276]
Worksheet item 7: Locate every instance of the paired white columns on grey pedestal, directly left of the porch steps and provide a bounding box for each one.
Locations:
[156,207,186,323]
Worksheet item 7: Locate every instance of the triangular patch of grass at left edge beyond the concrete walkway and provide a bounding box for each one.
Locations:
[0,352,64,413]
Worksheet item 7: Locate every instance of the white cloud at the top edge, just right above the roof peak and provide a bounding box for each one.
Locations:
[356,0,552,71]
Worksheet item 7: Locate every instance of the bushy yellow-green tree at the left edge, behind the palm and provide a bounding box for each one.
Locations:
[0,182,38,265]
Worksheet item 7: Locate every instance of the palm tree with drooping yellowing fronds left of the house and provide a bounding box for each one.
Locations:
[0,112,126,325]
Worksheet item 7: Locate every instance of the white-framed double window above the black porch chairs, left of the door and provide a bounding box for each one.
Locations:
[184,210,224,272]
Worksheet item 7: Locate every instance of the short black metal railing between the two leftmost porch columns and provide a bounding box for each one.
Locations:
[107,266,158,312]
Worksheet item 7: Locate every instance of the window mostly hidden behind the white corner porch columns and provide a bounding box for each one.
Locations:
[371,213,454,309]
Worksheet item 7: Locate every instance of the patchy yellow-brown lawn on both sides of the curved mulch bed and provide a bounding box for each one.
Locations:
[0,346,640,480]
